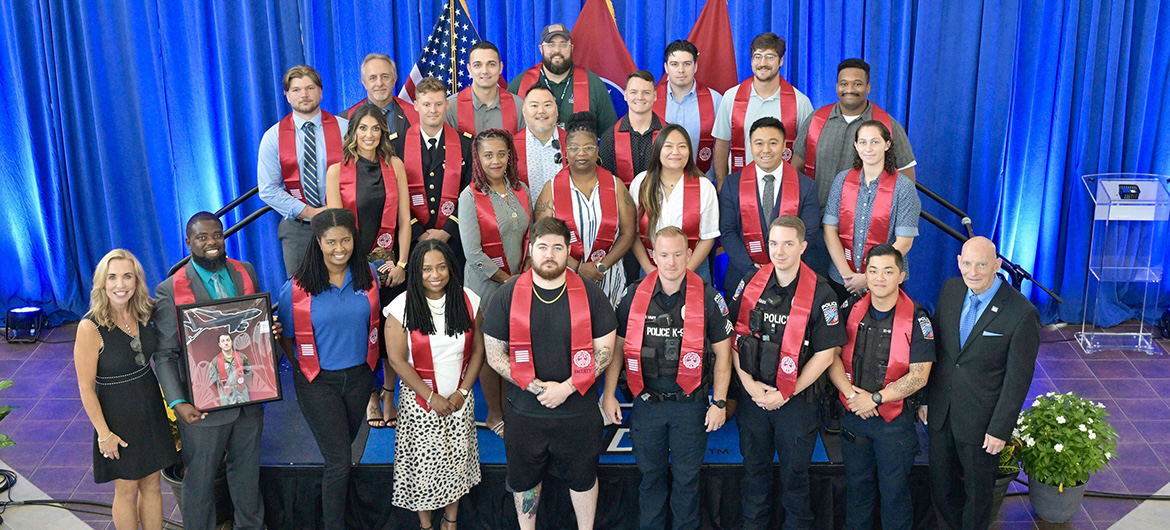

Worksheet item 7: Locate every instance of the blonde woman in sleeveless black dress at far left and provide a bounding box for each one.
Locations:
[74,248,179,529]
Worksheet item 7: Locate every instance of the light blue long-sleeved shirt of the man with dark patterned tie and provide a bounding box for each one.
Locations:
[256,112,350,219]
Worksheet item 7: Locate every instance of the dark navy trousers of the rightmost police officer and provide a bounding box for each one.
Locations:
[841,411,918,530]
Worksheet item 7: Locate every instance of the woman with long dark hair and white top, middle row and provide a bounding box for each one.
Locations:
[629,124,720,284]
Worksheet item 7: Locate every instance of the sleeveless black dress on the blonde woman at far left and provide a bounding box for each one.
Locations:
[87,316,179,483]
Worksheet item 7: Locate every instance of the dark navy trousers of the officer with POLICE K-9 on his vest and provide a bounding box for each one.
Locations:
[629,399,707,530]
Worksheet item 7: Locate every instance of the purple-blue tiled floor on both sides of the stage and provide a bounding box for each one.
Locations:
[0,326,1170,529]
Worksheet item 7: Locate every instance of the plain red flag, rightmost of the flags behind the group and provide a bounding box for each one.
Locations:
[687,0,739,92]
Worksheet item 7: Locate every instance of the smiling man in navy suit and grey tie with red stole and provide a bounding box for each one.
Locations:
[720,116,827,294]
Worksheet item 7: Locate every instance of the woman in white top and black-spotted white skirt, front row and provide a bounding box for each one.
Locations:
[385,241,477,530]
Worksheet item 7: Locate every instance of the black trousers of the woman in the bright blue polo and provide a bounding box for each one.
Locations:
[293,363,373,530]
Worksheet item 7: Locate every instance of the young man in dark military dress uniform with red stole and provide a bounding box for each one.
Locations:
[402,77,472,270]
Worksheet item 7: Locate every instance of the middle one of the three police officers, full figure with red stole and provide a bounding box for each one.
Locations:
[729,215,846,530]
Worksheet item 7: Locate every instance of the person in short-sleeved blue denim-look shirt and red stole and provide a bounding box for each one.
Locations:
[824,119,922,301]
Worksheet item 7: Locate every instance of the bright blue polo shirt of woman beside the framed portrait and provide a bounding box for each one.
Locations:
[276,266,378,370]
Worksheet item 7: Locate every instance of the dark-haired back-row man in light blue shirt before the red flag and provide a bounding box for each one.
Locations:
[654,40,723,178]
